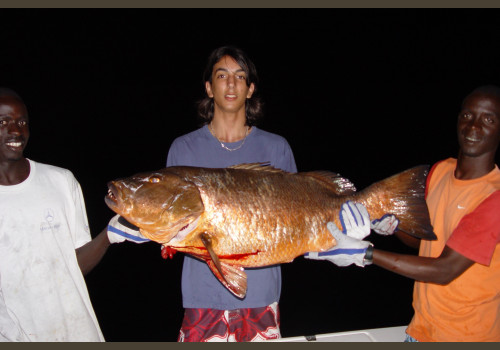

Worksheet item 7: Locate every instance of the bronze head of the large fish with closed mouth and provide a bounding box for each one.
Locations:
[105,171,204,243]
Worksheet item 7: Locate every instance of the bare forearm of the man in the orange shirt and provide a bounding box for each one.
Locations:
[373,246,474,285]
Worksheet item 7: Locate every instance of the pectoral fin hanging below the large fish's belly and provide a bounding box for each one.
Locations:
[200,233,247,298]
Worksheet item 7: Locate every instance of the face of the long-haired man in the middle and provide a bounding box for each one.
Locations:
[205,56,255,113]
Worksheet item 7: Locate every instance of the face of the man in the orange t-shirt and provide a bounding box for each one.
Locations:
[457,93,500,157]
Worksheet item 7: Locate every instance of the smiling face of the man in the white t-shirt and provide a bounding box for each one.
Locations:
[0,96,30,161]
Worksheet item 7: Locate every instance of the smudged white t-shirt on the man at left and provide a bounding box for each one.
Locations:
[0,160,104,341]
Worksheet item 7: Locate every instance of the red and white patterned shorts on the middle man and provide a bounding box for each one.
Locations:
[178,303,281,342]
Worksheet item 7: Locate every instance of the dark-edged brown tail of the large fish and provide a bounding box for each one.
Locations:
[359,165,437,240]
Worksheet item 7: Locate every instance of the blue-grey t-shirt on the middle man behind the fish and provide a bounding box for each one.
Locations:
[167,126,297,310]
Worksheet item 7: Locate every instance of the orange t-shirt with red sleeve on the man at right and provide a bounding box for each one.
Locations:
[407,158,500,342]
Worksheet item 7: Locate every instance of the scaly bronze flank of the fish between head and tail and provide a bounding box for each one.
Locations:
[170,167,341,267]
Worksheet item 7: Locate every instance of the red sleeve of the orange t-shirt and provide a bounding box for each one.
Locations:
[446,191,500,266]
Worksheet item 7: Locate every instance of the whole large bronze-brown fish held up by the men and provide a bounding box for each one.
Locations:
[105,164,436,298]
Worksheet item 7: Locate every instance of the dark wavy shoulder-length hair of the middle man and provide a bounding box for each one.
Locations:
[197,46,263,126]
